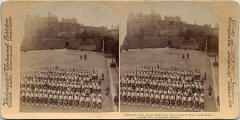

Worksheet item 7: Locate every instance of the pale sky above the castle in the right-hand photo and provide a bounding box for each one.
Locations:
[120,2,218,45]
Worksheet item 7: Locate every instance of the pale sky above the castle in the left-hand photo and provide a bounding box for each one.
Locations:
[26,2,118,28]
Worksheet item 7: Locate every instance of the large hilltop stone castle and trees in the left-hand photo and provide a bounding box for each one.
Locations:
[21,12,118,50]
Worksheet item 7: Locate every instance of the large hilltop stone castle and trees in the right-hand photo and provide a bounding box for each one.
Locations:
[122,10,218,49]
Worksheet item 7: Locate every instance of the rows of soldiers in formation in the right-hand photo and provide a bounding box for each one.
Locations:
[120,65,207,111]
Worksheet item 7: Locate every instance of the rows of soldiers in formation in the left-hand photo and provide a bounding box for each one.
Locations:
[21,66,104,111]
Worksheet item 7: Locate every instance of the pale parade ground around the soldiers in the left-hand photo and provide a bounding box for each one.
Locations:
[20,49,118,112]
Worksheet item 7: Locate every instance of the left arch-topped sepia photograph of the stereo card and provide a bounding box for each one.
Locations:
[19,2,119,113]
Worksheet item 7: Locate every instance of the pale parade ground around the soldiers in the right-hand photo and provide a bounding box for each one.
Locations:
[120,48,219,112]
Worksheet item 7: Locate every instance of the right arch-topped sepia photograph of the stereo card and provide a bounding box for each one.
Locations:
[120,2,220,112]
